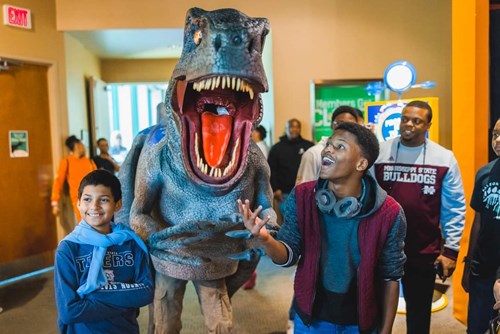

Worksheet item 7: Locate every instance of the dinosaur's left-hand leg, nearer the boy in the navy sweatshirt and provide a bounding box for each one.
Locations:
[153,272,187,334]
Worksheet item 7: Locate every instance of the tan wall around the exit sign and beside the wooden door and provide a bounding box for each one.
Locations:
[0,0,68,162]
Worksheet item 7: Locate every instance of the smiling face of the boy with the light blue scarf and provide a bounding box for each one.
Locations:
[78,184,122,234]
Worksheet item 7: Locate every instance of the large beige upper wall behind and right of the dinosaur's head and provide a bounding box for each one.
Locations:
[56,0,451,147]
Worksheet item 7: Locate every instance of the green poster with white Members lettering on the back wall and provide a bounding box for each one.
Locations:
[311,79,386,142]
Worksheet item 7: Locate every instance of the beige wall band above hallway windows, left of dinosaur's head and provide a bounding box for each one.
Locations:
[101,59,177,82]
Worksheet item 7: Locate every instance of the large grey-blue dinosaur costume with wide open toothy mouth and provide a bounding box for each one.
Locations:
[115,8,276,333]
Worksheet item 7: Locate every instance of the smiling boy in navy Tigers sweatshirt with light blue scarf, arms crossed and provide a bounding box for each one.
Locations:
[54,170,154,334]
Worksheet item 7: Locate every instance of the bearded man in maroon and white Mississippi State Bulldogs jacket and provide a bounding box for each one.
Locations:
[374,101,465,334]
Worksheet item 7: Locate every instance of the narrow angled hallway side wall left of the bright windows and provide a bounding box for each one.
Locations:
[64,33,101,145]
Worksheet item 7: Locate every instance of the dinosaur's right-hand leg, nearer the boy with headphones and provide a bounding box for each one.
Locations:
[193,278,233,334]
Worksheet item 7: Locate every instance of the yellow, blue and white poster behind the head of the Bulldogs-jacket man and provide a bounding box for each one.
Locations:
[364,97,439,143]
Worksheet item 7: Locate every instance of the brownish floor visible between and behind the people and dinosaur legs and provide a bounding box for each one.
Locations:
[0,258,465,334]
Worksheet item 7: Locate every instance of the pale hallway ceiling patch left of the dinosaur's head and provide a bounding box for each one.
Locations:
[68,29,183,59]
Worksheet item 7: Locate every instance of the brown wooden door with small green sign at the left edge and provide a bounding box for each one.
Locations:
[0,63,57,266]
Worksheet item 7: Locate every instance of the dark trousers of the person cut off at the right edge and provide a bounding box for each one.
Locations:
[467,275,496,334]
